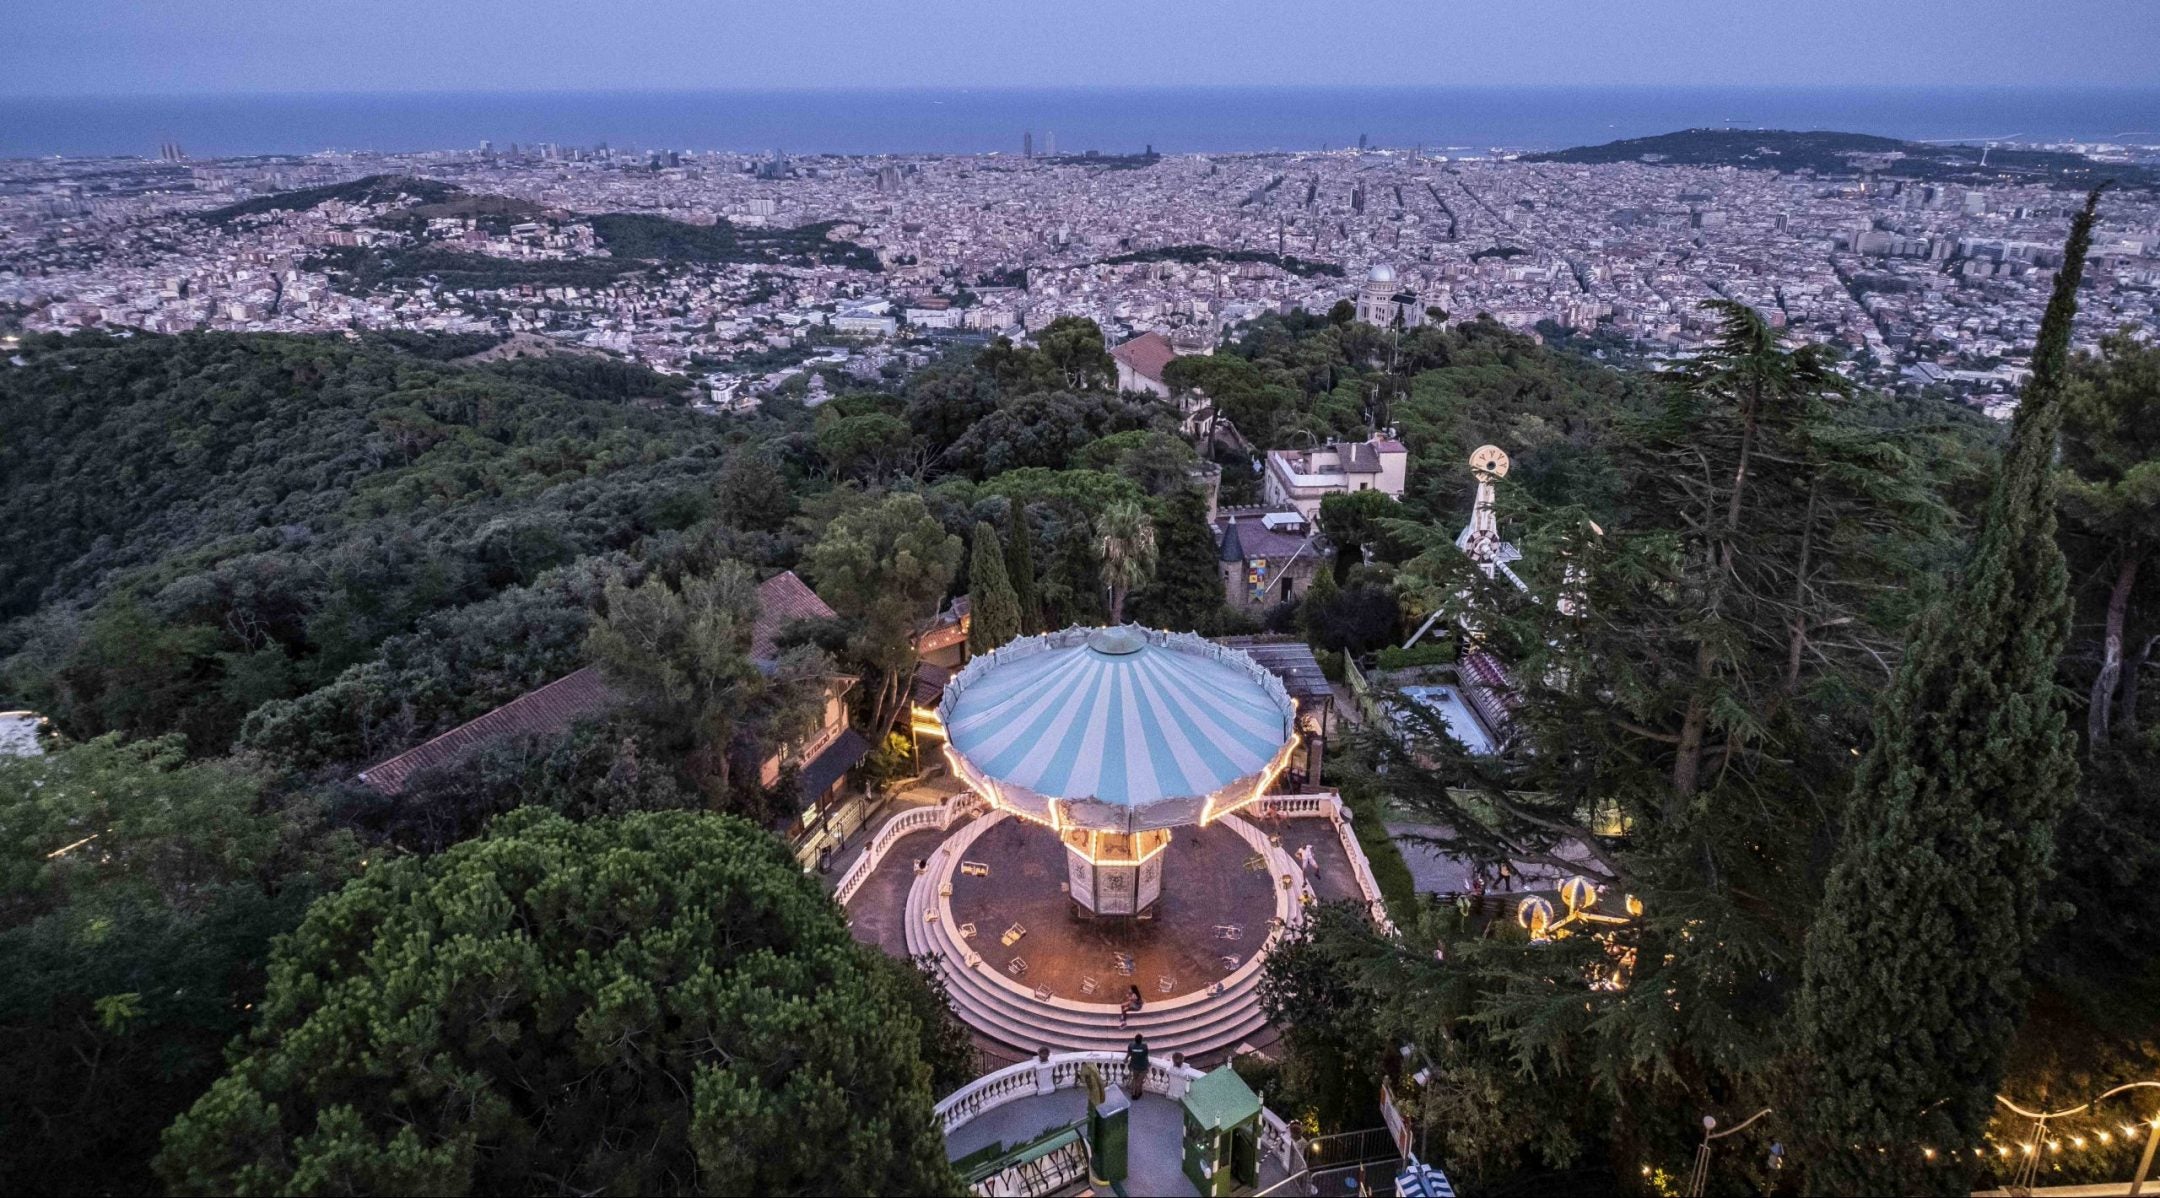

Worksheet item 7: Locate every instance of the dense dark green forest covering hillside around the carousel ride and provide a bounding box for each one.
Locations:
[0,192,2160,1194]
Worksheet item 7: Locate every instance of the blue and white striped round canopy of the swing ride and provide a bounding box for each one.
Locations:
[940,626,1298,831]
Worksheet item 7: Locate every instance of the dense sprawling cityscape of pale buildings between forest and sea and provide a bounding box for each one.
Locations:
[0,134,2160,414]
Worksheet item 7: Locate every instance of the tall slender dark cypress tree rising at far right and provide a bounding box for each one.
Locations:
[1799,190,2100,1194]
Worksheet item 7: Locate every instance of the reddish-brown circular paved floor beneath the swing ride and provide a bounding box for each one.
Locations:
[942,820,1277,1004]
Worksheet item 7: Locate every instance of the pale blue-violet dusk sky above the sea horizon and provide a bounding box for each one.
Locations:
[0,0,2160,97]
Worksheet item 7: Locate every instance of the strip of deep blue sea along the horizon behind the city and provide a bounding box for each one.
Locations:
[0,86,2160,158]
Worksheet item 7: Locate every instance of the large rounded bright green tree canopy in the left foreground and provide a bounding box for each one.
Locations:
[158,812,957,1194]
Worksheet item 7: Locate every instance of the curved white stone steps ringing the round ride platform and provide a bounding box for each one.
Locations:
[905,812,1302,1060]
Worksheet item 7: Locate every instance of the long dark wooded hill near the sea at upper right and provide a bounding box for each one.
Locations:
[1523,130,2156,188]
